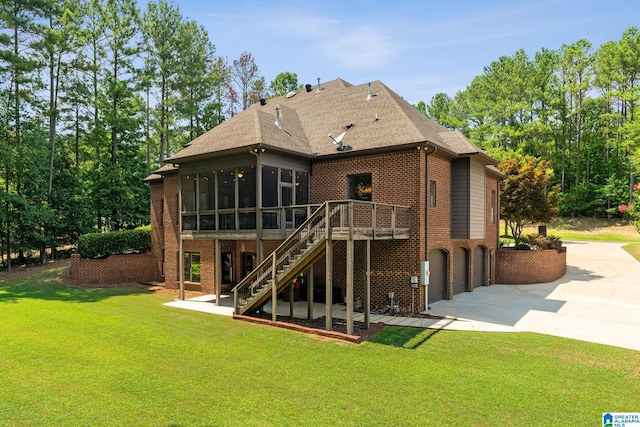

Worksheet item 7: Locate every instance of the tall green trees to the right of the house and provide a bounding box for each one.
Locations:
[416,27,640,221]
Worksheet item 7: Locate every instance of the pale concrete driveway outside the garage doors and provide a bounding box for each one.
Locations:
[429,241,640,350]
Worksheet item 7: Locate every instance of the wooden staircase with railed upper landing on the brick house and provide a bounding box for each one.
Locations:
[233,200,411,314]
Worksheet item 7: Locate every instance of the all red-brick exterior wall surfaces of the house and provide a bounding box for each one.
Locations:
[151,148,499,310]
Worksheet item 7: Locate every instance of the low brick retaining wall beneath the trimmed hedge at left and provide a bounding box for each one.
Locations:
[69,254,157,285]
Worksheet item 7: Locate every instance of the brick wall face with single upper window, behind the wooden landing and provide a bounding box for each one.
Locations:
[311,148,426,307]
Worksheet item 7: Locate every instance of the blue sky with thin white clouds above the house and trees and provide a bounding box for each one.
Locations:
[166,0,640,104]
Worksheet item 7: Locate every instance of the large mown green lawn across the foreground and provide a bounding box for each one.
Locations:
[0,269,640,426]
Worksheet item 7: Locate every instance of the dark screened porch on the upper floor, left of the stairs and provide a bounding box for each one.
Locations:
[178,153,314,239]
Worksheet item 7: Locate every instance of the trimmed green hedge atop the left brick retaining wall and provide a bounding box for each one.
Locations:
[78,226,151,259]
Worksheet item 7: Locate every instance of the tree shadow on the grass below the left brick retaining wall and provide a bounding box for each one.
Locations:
[0,267,149,304]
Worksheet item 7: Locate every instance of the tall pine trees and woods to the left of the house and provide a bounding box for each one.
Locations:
[0,0,297,268]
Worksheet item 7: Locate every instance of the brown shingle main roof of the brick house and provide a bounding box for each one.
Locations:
[167,79,496,163]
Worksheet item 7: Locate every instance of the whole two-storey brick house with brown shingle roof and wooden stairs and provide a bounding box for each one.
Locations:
[147,79,501,334]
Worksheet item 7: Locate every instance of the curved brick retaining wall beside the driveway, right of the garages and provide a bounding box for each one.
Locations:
[496,248,567,285]
